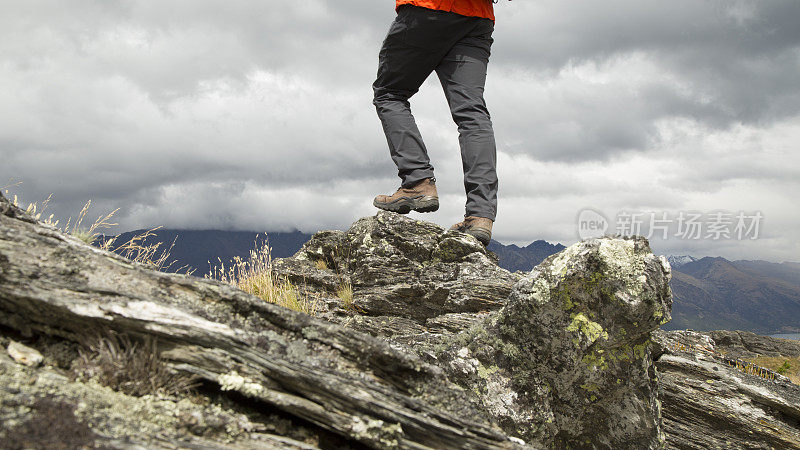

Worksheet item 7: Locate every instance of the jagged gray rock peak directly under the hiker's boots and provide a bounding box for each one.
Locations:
[275,211,520,334]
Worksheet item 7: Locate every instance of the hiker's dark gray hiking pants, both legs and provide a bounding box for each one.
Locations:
[372,5,497,220]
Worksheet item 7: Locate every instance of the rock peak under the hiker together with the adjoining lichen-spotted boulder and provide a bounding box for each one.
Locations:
[277,212,671,448]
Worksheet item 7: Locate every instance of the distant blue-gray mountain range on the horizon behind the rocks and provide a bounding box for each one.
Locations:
[106,229,800,334]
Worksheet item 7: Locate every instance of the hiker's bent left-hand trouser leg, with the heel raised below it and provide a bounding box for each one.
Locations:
[372,6,454,187]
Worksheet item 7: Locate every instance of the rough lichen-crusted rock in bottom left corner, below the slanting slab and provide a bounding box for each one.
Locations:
[0,355,321,448]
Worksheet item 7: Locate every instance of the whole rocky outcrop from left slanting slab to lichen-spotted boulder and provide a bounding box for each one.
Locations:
[0,192,671,448]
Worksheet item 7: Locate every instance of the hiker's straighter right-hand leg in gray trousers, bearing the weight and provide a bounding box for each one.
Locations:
[436,19,497,220]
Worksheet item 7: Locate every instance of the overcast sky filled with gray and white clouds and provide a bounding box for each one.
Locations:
[0,0,800,261]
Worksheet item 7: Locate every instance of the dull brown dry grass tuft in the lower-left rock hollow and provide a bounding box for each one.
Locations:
[71,332,198,397]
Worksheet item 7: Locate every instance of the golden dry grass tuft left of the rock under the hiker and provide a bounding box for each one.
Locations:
[206,242,317,316]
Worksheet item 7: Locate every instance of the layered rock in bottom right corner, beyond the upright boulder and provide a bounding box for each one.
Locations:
[653,331,800,449]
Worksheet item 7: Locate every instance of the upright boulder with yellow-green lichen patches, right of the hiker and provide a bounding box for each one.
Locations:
[430,237,672,448]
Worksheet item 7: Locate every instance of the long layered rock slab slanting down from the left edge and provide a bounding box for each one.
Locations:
[0,192,517,449]
